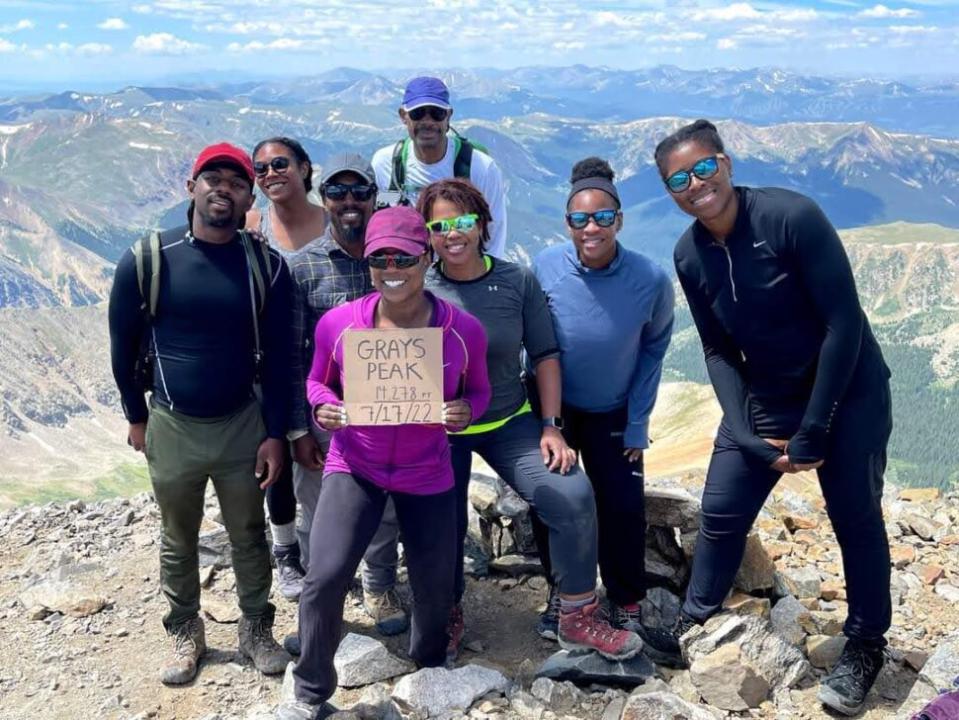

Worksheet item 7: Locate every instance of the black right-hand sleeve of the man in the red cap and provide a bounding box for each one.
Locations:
[259,251,293,440]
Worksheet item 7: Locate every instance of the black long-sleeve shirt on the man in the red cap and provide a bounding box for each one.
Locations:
[109,226,292,439]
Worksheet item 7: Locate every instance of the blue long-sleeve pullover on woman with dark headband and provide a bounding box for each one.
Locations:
[533,243,674,448]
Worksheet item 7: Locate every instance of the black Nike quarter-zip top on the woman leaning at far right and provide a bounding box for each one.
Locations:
[674,187,889,464]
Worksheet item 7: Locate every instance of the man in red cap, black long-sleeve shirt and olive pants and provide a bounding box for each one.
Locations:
[109,143,291,684]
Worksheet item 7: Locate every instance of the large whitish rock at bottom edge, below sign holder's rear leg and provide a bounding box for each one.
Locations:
[392,665,510,717]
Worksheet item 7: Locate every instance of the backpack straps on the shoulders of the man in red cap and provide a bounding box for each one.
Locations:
[133,229,273,391]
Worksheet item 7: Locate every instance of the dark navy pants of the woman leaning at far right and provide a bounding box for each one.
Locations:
[683,383,892,643]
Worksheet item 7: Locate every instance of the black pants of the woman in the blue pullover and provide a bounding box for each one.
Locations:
[533,406,646,605]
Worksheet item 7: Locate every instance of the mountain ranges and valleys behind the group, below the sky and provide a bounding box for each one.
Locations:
[0,66,959,506]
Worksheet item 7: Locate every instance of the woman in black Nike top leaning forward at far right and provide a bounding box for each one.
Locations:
[656,120,892,714]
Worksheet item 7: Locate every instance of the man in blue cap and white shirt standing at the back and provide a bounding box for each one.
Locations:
[373,77,506,258]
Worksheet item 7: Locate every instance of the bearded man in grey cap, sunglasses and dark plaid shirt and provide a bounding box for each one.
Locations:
[286,153,409,652]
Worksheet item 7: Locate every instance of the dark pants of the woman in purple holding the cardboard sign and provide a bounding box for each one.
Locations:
[293,473,456,703]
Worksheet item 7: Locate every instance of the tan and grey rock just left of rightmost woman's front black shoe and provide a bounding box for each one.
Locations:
[689,644,769,712]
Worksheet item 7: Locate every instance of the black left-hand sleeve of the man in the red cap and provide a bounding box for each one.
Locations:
[107,250,149,423]
